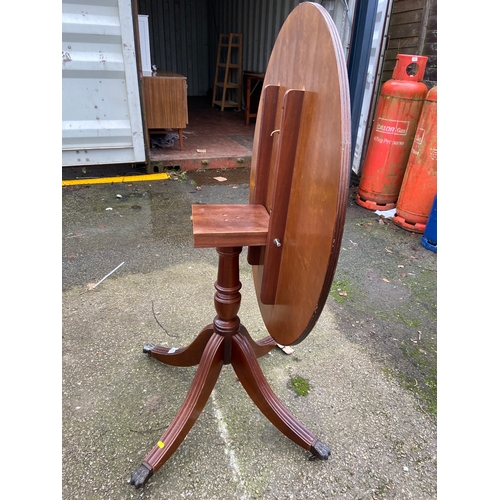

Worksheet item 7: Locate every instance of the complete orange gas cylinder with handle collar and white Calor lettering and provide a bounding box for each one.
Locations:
[356,54,428,210]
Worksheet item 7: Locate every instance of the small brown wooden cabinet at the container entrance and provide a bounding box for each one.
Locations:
[143,72,188,149]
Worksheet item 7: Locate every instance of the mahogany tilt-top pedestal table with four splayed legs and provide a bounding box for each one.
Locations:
[130,2,351,488]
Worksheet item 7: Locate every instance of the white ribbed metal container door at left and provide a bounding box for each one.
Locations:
[62,0,146,167]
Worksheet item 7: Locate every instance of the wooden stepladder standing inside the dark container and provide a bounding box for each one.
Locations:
[212,33,242,111]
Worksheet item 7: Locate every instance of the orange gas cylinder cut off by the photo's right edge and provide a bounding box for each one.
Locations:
[393,87,437,233]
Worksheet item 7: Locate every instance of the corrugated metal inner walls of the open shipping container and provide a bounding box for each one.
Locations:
[137,0,356,96]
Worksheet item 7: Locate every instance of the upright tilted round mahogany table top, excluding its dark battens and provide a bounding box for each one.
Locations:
[250,2,351,345]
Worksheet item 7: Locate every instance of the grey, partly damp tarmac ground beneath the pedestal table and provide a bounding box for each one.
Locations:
[62,169,437,500]
